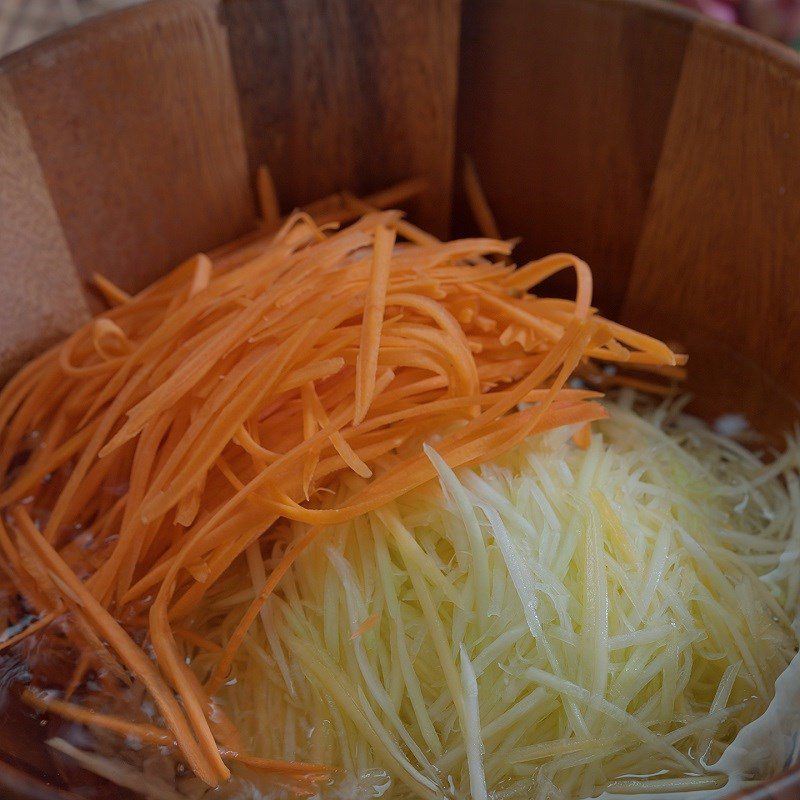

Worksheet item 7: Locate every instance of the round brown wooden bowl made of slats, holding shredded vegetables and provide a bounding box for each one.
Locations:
[0,0,800,800]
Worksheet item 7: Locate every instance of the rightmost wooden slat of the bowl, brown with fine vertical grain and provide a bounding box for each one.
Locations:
[624,24,800,426]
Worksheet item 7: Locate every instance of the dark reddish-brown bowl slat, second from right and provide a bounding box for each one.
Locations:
[457,0,692,315]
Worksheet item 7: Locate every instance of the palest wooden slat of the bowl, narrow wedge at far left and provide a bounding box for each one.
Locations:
[0,74,88,381]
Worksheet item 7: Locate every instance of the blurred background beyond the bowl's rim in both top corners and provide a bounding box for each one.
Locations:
[0,0,800,55]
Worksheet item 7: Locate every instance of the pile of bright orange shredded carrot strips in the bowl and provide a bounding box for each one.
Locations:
[0,172,682,791]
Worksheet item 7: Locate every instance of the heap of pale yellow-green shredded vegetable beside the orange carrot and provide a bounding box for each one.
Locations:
[193,395,800,800]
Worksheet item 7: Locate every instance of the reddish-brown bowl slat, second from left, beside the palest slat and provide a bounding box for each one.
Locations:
[2,0,254,296]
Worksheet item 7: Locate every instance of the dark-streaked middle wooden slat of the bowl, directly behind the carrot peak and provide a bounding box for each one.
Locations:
[221,0,459,234]
